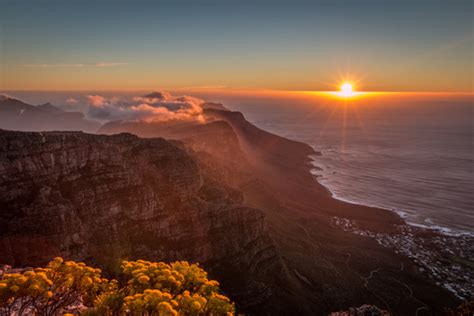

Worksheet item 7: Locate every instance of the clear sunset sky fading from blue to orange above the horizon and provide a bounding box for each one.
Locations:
[0,0,474,92]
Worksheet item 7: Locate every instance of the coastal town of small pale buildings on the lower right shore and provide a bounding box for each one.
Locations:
[332,216,474,300]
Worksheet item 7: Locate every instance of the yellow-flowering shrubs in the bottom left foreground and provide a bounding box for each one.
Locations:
[0,258,234,316]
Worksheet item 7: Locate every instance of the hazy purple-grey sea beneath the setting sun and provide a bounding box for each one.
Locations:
[10,92,474,235]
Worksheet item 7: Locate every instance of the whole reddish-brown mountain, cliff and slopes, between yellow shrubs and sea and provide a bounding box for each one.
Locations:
[0,101,472,315]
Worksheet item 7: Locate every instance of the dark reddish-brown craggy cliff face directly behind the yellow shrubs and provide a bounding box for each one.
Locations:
[0,131,277,302]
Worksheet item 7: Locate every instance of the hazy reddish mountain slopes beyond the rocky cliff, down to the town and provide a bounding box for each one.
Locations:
[97,109,457,315]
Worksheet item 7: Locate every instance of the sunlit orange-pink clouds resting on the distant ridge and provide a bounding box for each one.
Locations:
[87,92,204,122]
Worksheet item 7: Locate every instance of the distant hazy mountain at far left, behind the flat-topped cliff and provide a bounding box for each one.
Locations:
[0,96,100,132]
